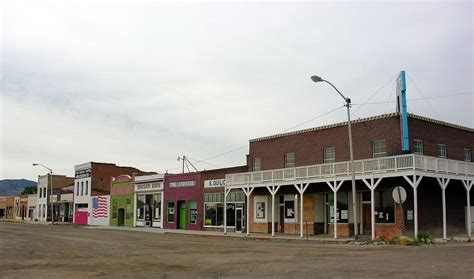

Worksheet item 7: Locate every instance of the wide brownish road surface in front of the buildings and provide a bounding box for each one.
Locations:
[0,222,474,278]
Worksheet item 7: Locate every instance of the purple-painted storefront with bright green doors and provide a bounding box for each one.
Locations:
[164,172,203,230]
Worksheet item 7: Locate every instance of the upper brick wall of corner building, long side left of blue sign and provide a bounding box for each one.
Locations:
[248,114,401,171]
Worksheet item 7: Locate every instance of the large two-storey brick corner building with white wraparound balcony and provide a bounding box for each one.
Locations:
[226,113,474,238]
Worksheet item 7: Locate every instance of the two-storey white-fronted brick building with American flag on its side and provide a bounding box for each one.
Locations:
[73,162,153,225]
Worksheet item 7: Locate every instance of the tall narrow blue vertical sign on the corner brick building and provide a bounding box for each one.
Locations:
[397,71,410,152]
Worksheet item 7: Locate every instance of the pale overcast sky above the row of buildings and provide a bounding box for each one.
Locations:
[0,1,474,180]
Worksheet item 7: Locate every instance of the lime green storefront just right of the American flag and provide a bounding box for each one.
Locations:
[110,195,135,227]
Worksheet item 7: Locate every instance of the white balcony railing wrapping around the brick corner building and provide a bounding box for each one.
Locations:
[226,154,474,186]
